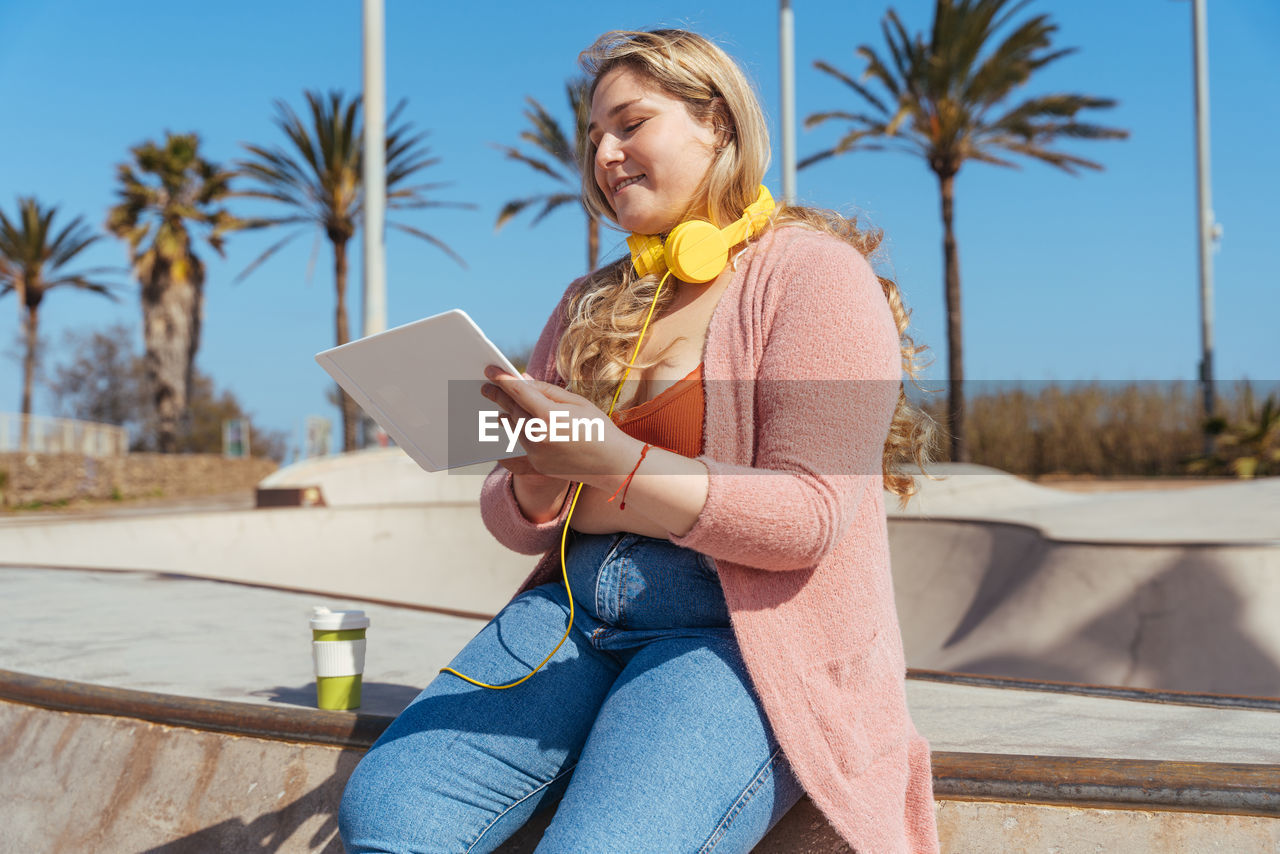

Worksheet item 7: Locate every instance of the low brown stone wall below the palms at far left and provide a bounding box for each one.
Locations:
[0,453,278,507]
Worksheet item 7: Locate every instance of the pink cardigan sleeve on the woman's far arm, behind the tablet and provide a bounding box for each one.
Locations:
[480,279,581,554]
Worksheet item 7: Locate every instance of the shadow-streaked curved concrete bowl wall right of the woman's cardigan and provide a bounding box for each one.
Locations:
[890,519,1280,697]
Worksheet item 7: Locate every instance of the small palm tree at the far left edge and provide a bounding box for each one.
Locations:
[0,196,115,449]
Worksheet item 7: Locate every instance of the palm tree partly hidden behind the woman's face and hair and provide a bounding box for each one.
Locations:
[494,77,600,273]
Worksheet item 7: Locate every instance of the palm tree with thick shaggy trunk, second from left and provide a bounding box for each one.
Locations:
[106,132,244,453]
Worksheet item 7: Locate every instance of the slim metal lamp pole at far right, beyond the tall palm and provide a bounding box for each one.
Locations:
[1192,0,1215,455]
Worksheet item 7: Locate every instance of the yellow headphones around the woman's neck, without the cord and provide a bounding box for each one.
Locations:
[627,184,774,284]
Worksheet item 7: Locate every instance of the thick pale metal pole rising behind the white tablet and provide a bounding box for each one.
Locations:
[362,0,387,335]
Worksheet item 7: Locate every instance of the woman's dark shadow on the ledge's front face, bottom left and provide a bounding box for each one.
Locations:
[142,750,361,854]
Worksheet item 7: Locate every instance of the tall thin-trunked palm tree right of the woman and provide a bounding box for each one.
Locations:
[799,0,1129,462]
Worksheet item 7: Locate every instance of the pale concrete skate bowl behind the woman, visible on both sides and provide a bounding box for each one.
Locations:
[0,458,1280,697]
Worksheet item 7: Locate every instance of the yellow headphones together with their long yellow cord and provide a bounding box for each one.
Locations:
[440,184,774,689]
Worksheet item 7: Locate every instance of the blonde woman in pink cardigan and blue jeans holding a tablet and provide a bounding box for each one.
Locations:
[339,31,938,854]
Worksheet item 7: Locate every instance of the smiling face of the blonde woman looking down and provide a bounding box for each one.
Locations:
[588,68,716,234]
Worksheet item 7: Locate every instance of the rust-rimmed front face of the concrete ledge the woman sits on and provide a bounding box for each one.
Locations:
[0,671,1280,854]
